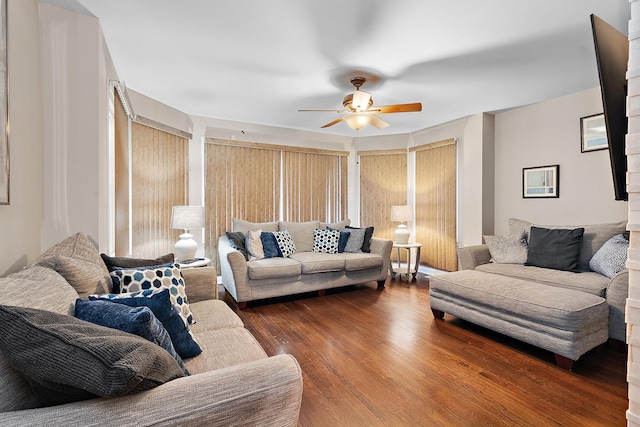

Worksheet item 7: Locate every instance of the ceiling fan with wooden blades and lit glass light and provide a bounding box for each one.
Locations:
[298,77,422,130]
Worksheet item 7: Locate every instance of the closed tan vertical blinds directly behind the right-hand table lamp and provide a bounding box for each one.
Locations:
[358,150,407,244]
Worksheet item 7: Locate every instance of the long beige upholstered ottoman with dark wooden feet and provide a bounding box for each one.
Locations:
[429,270,609,370]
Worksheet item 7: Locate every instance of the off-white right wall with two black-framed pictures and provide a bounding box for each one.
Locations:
[495,88,627,234]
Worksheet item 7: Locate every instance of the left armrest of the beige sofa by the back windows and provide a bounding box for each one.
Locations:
[218,236,252,302]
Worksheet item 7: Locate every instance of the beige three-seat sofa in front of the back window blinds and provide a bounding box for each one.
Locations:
[218,219,393,309]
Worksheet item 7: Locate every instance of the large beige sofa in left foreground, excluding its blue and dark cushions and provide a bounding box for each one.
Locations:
[0,234,302,426]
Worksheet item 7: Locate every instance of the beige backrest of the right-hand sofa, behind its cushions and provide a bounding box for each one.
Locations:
[509,218,627,271]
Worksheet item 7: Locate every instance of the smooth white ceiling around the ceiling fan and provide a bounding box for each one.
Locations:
[46,0,630,136]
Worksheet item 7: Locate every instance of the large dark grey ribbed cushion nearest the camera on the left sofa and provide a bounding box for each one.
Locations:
[0,306,184,406]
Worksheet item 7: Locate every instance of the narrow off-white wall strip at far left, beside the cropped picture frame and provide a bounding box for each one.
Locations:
[0,0,43,276]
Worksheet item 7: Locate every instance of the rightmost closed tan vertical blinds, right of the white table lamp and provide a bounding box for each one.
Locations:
[412,139,458,271]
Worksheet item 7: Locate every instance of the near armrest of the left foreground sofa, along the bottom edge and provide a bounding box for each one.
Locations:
[0,354,302,426]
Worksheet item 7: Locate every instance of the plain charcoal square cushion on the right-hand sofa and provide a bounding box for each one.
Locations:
[525,226,584,273]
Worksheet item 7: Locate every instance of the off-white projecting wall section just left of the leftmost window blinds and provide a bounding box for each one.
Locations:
[39,3,117,250]
